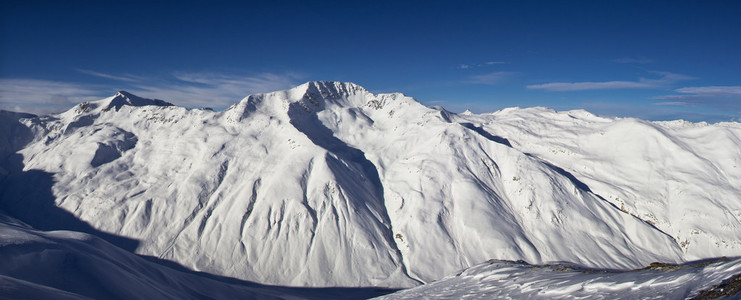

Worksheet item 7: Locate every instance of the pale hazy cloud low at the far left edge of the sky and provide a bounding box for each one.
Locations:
[0,78,115,114]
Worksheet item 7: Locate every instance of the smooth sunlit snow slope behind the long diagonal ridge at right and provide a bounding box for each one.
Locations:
[459,108,741,260]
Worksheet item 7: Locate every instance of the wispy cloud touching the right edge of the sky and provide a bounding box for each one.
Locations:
[652,86,741,110]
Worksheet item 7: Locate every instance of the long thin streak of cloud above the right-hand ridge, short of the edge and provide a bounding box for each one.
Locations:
[526,72,695,92]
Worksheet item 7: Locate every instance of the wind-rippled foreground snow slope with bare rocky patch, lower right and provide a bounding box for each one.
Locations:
[378,259,741,299]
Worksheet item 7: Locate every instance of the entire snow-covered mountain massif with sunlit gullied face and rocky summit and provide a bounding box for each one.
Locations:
[0,82,741,296]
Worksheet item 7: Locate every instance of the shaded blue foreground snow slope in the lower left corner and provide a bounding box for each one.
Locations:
[0,214,295,299]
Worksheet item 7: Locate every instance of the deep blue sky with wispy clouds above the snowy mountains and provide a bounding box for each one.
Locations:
[0,0,741,122]
